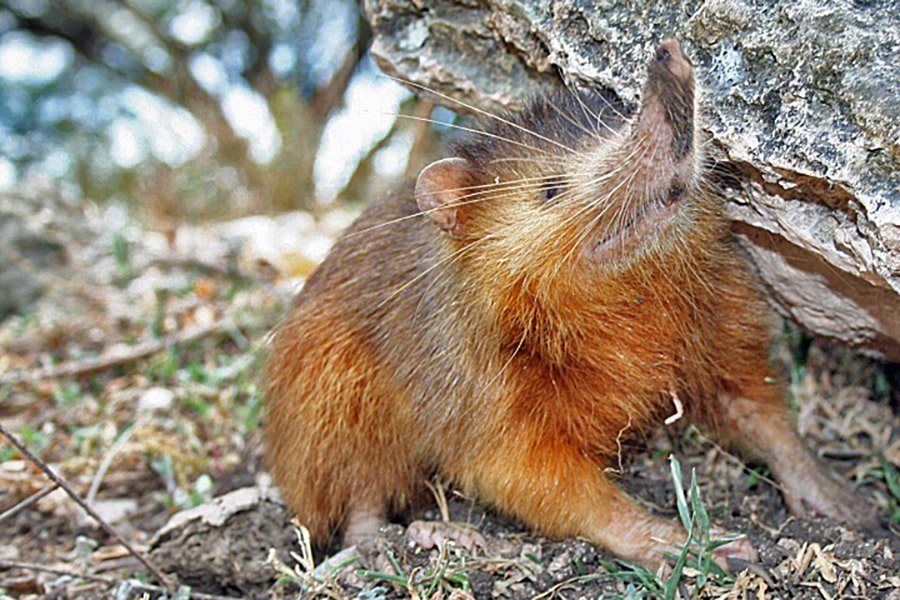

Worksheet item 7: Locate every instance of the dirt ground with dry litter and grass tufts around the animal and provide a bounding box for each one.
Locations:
[0,195,900,599]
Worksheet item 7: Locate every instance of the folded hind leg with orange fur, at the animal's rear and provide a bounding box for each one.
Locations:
[265,318,417,546]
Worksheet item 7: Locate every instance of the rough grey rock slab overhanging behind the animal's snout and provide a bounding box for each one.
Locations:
[365,0,900,360]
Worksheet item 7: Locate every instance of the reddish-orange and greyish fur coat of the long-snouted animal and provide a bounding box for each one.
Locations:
[266,38,880,564]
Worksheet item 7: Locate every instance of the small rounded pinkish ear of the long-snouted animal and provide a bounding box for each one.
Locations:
[416,158,472,240]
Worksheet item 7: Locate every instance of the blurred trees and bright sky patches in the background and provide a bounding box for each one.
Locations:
[0,0,439,230]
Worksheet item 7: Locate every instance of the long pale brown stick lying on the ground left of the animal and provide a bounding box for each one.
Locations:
[0,319,233,385]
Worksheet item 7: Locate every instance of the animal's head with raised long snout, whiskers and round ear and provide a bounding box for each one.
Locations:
[416,40,716,338]
